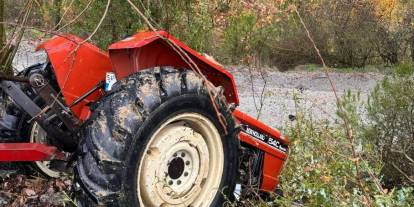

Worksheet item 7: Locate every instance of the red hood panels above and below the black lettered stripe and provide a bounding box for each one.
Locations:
[233,110,289,192]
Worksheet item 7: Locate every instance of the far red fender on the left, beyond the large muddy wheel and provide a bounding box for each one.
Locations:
[37,35,112,118]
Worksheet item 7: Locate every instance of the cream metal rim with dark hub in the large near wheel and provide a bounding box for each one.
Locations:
[137,113,224,206]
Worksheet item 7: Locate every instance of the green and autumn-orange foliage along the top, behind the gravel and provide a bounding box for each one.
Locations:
[6,0,414,70]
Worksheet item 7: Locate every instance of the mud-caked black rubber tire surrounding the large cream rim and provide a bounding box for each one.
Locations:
[75,67,238,206]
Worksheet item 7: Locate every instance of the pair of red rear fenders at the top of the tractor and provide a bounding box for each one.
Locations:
[37,31,239,120]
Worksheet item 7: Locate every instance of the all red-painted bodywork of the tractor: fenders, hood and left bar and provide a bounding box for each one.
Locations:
[0,31,288,196]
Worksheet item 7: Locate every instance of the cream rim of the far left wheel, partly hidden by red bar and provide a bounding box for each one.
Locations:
[30,122,60,178]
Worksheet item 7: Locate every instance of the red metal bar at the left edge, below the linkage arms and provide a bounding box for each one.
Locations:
[0,143,65,162]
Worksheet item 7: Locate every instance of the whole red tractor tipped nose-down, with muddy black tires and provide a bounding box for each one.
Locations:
[0,31,288,206]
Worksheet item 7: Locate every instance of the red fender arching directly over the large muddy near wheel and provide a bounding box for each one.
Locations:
[109,31,239,105]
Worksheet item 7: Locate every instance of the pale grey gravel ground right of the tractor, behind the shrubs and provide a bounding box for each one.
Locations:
[229,66,384,128]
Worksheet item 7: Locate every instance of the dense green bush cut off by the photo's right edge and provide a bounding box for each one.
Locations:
[367,64,414,187]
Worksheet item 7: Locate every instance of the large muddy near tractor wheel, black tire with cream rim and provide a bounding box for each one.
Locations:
[77,67,238,207]
